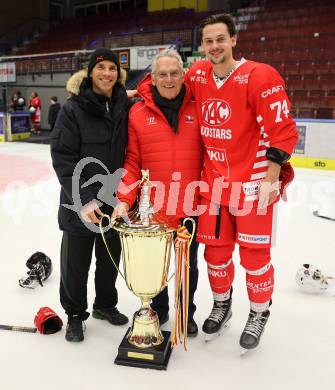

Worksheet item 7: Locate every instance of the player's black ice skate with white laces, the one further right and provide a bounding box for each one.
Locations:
[240,310,270,354]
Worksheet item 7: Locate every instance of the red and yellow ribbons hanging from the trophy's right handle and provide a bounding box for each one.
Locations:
[171,219,194,351]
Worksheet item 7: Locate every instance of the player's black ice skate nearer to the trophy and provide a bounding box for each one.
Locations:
[202,298,232,342]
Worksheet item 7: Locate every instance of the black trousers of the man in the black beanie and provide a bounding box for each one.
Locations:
[60,232,121,320]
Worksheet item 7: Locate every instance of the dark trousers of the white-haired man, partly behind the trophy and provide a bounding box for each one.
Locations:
[151,218,199,317]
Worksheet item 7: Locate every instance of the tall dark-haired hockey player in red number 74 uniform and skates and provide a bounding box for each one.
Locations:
[186,14,297,349]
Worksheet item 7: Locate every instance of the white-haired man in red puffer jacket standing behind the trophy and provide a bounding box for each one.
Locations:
[113,49,203,337]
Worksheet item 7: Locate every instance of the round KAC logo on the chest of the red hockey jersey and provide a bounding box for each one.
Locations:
[202,99,231,126]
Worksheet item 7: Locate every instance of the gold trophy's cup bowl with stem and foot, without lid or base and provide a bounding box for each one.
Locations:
[115,227,174,349]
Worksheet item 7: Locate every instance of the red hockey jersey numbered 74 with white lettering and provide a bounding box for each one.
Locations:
[185,60,297,206]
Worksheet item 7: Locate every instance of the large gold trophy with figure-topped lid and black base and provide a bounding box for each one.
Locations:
[101,171,192,370]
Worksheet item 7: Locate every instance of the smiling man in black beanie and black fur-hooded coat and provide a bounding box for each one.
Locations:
[51,48,130,341]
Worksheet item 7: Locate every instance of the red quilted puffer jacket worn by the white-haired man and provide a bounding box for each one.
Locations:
[118,75,203,218]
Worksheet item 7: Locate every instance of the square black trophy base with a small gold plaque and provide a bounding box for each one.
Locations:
[114,328,171,370]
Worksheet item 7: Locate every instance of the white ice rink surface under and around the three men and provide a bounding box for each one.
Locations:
[0,143,335,390]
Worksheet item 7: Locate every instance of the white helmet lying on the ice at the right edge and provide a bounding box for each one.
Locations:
[295,264,335,293]
